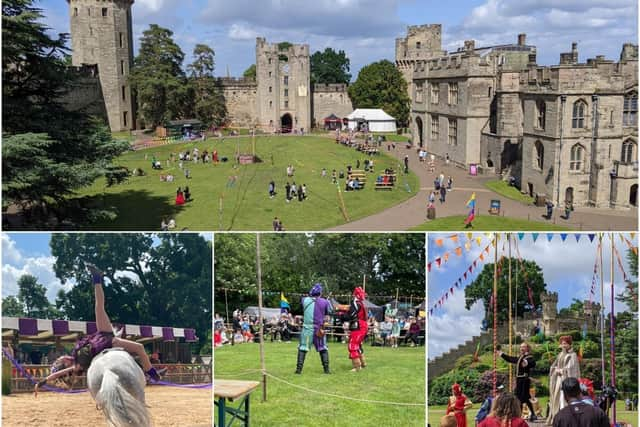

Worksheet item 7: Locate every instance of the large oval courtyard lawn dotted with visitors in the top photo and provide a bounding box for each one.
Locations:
[71,136,418,230]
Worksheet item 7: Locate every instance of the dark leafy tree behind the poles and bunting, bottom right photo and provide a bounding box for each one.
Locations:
[464,257,546,321]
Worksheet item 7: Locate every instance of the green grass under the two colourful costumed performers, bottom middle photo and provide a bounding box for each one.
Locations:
[214,342,425,427]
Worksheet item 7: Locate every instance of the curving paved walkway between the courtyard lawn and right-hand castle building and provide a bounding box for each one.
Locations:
[331,144,638,231]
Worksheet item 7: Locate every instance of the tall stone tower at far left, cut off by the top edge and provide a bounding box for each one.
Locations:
[67,0,135,132]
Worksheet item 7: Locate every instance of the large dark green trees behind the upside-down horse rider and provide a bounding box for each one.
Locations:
[50,233,213,352]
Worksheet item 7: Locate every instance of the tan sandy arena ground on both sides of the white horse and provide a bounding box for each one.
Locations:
[2,386,213,427]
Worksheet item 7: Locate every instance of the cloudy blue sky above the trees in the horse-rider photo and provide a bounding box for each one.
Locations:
[1,233,212,303]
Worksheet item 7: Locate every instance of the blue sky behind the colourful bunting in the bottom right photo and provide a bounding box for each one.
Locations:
[427,233,638,359]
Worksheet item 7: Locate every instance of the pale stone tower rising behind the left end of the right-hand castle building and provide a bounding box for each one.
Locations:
[396,24,444,98]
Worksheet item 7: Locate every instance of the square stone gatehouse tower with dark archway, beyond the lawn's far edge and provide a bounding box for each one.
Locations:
[255,37,311,131]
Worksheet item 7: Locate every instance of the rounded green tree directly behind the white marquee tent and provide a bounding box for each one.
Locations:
[349,59,411,126]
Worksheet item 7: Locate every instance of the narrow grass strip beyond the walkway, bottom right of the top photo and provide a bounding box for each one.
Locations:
[412,215,570,231]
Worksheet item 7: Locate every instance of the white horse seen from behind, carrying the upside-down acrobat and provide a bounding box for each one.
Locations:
[87,348,151,427]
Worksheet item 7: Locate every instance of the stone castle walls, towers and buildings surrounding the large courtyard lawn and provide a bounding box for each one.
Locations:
[67,0,638,209]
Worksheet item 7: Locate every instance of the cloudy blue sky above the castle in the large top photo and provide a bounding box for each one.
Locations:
[38,0,638,79]
